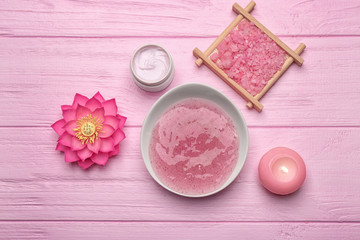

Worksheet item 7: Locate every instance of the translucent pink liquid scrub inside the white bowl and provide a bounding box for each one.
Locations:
[149,98,239,195]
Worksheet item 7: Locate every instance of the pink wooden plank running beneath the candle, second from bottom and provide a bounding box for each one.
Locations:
[0,127,360,221]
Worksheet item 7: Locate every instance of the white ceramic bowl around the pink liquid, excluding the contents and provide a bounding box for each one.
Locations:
[140,83,249,197]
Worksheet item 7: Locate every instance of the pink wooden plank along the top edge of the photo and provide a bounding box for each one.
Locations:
[0,0,360,37]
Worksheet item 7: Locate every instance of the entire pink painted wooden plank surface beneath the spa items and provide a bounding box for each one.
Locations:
[0,0,360,240]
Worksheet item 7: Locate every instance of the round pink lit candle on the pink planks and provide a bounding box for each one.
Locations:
[258,147,306,195]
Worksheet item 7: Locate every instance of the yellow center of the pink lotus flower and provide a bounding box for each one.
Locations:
[74,114,103,144]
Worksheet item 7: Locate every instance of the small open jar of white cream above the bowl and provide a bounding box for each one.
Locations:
[130,44,174,92]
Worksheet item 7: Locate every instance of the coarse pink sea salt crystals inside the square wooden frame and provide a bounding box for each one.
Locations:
[210,20,286,96]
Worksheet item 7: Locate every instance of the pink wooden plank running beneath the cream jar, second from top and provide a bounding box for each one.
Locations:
[0,37,360,126]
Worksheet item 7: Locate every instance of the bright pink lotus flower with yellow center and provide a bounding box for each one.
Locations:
[51,92,126,169]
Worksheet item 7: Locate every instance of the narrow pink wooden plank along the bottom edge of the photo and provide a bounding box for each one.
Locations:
[0,221,360,240]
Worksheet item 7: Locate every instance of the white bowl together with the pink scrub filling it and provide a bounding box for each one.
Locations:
[141,83,248,197]
